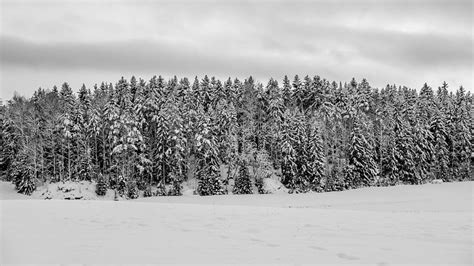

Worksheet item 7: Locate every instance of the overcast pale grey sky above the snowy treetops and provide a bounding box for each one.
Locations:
[0,0,473,99]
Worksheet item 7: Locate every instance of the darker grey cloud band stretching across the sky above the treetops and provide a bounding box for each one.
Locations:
[0,21,473,75]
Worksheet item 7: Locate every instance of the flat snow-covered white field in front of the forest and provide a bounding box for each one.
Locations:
[0,182,474,265]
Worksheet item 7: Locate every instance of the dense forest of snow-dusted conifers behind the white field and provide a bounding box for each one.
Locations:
[0,75,474,198]
